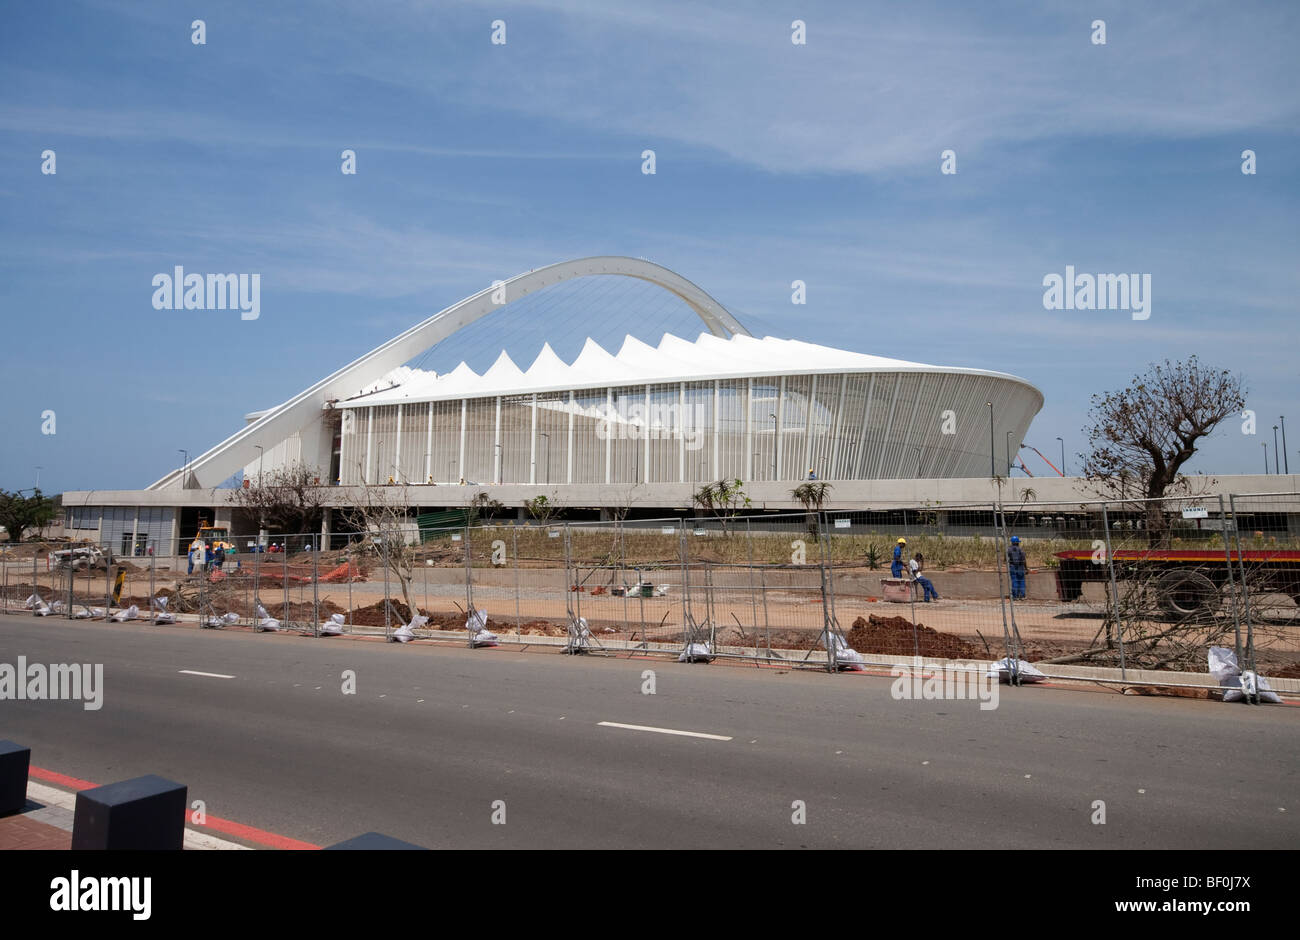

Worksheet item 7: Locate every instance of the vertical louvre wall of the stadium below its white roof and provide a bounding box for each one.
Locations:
[338,371,1041,489]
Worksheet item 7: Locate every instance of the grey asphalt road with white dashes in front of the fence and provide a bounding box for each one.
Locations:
[0,616,1300,849]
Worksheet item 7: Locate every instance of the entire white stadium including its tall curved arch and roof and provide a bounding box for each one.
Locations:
[65,257,1043,551]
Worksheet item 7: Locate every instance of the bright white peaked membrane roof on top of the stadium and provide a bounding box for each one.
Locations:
[338,333,1023,408]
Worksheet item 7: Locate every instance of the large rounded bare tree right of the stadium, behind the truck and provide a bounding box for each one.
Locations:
[1084,356,1245,545]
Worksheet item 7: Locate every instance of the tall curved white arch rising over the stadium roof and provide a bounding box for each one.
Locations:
[148,255,749,490]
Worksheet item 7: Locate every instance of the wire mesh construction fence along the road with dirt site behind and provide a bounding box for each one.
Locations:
[0,491,1300,684]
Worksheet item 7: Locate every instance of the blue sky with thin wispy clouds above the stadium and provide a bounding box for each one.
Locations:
[0,0,1300,491]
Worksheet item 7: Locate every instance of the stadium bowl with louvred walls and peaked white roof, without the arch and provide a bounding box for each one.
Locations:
[338,333,1043,485]
